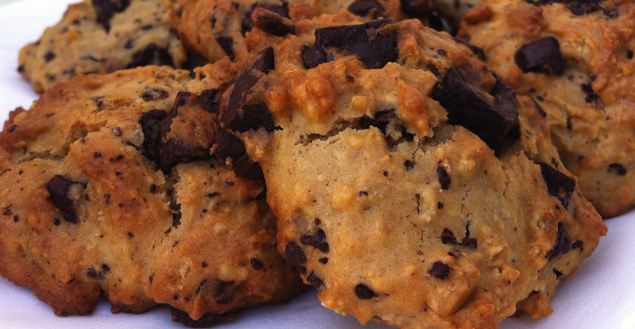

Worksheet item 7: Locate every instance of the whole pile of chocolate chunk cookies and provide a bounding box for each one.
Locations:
[0,0,635,328]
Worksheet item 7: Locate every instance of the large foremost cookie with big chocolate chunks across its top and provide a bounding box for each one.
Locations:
[219,12,606,328]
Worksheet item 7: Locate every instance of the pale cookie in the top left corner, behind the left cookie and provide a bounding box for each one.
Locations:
[18,0,187,93]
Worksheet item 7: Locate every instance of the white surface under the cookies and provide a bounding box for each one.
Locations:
[0,0,635,329]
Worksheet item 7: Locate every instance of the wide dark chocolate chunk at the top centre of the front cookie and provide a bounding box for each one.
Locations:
[315,19,399,69]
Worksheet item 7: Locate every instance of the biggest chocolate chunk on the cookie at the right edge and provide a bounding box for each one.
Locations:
[514,37,566,74]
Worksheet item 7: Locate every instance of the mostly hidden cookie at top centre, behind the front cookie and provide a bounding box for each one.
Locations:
[179,0,412,62]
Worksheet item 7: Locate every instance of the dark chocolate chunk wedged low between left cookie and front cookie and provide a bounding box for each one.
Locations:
[216,129,264,182]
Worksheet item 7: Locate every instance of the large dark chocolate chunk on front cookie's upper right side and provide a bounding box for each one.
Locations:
[432,67,518,150]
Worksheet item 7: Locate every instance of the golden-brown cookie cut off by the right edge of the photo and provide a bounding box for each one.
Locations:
[458,0,635,217]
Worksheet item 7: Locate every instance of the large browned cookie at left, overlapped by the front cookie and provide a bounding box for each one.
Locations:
[0,60,303,326]
